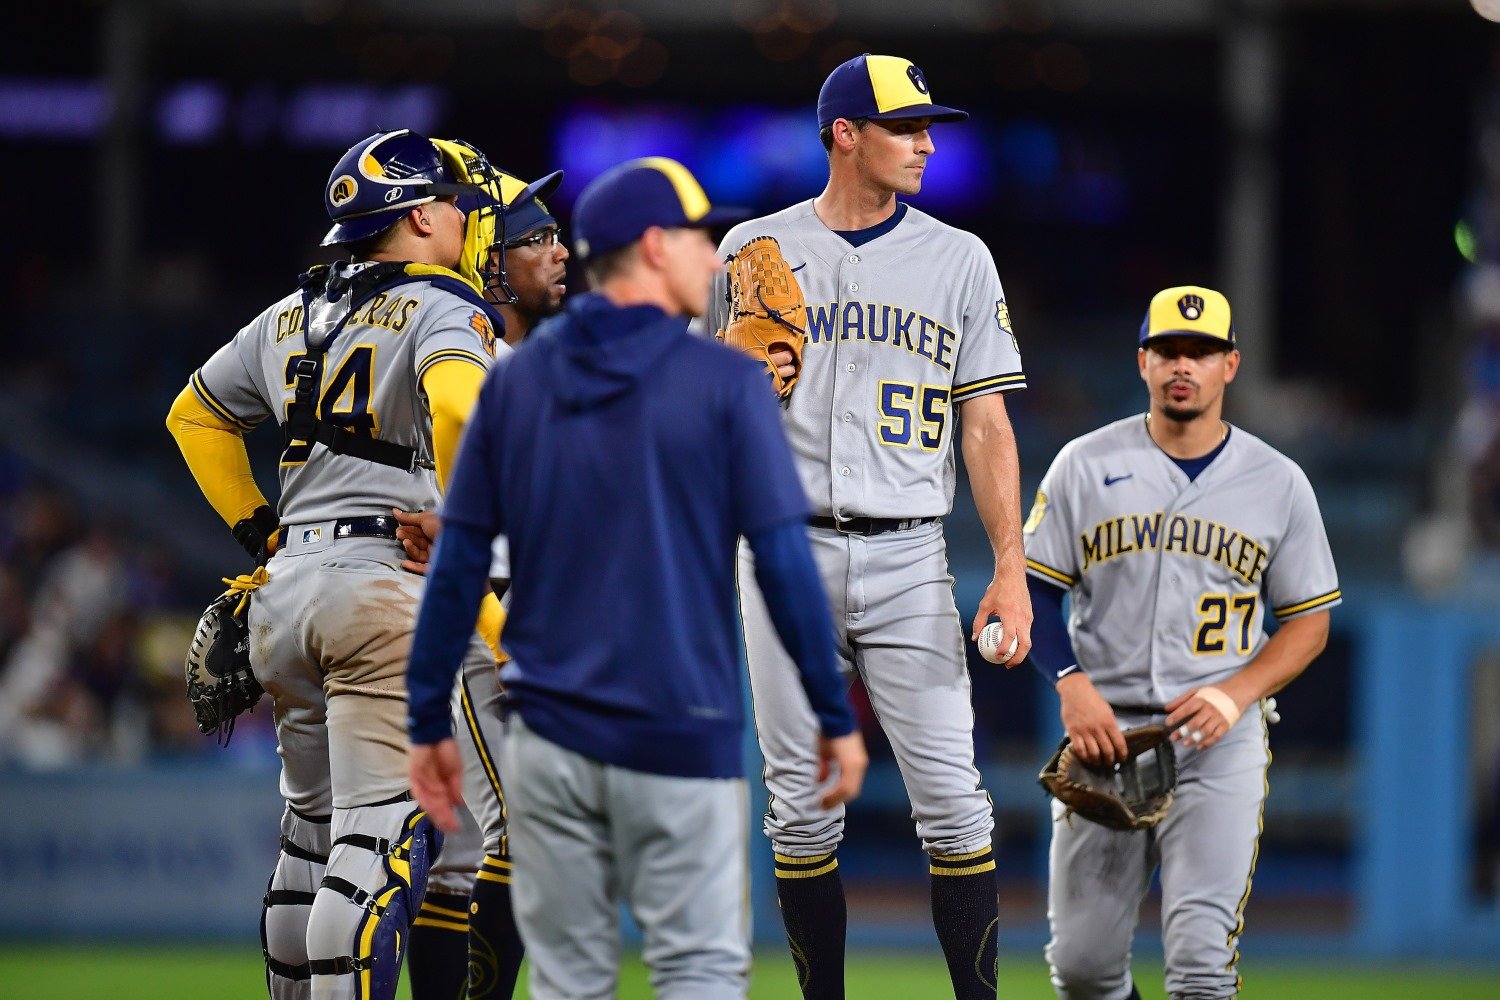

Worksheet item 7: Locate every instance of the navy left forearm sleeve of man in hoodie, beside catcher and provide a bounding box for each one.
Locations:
[407,523,491,744]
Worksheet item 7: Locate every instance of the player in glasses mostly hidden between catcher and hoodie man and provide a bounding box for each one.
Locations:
[398,158,569,1000]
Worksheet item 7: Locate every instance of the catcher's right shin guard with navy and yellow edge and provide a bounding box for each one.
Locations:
[308,796,443,1000]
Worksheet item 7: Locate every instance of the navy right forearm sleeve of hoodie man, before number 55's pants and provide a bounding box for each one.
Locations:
[747,520,855,738]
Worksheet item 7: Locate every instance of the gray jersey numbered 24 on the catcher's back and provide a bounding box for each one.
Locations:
[192,265,503,525]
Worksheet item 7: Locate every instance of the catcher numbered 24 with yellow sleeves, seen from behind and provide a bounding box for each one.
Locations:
[168,129,500,999]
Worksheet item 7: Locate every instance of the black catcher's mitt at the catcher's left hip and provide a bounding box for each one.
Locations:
[183,567,267,747]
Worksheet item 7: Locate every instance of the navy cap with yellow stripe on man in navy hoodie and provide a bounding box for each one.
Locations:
[573,156,750,259]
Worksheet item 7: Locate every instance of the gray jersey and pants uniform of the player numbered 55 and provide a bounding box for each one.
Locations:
[704,201,1026,879]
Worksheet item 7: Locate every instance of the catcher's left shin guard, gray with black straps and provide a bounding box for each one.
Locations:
[261,807,330,1000]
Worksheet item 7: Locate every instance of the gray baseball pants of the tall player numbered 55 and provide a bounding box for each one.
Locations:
[738,522,995,858]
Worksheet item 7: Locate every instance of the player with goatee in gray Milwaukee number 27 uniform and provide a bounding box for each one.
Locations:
[1026,285,1340,1000]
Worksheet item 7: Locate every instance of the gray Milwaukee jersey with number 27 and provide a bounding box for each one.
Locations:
[1025,415,1340,705]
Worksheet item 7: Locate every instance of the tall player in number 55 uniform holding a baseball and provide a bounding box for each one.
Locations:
[707,55,1031,997]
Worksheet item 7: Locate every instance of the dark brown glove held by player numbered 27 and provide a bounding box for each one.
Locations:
[1037,726,1178,831]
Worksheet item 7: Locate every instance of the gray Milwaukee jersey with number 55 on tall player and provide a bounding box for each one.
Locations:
[704,201,1026,517]
